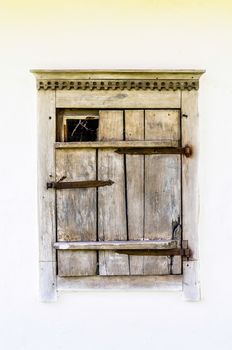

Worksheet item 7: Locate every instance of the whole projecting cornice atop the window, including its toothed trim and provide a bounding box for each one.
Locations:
[32,70,204,91]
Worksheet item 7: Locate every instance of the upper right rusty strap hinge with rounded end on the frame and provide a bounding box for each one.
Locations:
[115,145,192,158]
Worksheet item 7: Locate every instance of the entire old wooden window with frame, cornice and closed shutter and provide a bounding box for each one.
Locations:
[32,71,205,300]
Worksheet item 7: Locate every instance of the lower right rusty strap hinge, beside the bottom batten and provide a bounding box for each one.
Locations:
[115,241,191,258]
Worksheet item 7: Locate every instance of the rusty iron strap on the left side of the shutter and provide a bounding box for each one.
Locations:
[47,180,114,190]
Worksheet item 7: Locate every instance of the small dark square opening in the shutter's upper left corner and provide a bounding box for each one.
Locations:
[66,119,98,142]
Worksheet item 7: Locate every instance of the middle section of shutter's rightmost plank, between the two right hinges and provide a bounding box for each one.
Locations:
[144,155,181,239]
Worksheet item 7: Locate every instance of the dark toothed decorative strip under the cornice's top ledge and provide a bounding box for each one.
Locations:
[37,79,199,91]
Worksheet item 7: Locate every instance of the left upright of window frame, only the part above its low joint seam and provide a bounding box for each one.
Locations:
[38,91,56,261]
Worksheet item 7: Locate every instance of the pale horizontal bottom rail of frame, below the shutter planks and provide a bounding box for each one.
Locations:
[57,275,183,292]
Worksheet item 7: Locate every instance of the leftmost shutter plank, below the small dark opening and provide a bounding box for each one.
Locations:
[56,149,97,276]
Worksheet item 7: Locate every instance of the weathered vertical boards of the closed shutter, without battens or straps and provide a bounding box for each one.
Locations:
[56,109,181,276]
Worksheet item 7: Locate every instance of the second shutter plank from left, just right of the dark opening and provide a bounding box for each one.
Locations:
[98,110,129,275]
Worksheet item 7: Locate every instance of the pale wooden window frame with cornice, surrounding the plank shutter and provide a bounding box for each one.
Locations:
[32,70,204,301]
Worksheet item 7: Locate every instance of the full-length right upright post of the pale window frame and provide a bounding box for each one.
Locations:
[181,90,200,300]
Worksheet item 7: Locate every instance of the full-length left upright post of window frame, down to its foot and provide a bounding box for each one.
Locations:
[37,90,56,301]
